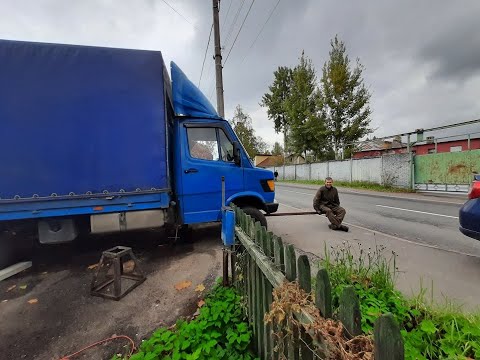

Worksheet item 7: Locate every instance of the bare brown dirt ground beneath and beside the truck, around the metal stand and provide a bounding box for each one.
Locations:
[0,226,222,360]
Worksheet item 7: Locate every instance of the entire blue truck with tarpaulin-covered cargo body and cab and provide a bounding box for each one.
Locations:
[0,40,278,268]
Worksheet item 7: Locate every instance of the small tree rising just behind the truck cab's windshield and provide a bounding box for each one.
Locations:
[230,105,268,159]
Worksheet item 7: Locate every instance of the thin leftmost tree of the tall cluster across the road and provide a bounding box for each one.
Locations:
[260,66,292,155]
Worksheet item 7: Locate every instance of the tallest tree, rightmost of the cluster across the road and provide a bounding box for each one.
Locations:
[318,36,372,158]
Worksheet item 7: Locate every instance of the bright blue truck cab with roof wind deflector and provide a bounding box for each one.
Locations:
[171,63,278,226]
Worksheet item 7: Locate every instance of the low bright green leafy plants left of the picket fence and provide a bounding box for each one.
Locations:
[112,285,255,360]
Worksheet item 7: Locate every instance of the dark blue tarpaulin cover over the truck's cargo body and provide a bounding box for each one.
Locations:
[0,40,169,202]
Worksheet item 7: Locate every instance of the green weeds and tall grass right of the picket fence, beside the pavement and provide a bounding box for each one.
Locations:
[320,242,480,360]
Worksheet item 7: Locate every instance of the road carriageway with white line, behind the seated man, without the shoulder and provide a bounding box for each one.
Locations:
[276,184,480,256]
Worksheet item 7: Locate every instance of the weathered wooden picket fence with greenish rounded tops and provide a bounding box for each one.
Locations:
[232,208,404,360]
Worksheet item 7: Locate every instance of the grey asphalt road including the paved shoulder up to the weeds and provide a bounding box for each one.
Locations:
[268,184,480,309]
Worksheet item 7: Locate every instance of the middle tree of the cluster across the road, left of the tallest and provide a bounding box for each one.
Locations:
[285,52,328,157]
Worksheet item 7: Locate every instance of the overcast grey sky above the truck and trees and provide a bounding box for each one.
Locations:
[0,0,480,144]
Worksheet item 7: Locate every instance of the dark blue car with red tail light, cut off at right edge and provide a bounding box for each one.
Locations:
[459,174,480,240]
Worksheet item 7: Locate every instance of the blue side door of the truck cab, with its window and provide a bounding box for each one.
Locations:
[179,123,244,224]
